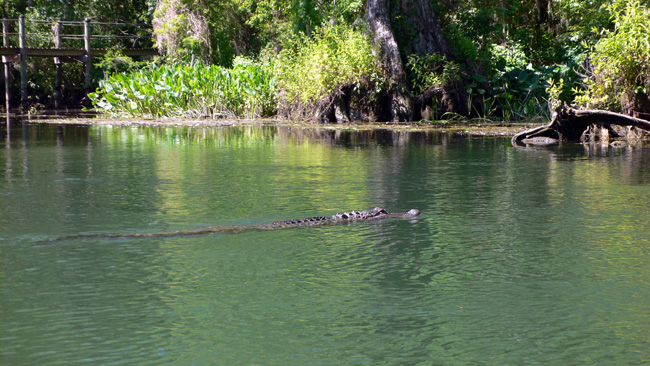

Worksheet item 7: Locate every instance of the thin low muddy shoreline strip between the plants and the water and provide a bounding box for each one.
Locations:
[9,111,542,136]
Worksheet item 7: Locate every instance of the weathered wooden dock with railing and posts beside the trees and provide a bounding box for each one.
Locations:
[0,15,158,111]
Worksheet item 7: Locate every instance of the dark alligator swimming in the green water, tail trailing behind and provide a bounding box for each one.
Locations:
[49,207,420,242]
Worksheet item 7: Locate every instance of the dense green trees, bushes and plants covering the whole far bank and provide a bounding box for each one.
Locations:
[3,0,650,120]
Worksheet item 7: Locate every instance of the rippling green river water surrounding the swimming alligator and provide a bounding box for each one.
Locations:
[0,125,650,366]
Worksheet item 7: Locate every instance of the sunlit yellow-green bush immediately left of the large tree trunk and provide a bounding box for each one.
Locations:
[275,25,384,104]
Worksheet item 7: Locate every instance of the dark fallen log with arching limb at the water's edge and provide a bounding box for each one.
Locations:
[512,105,650,145]
